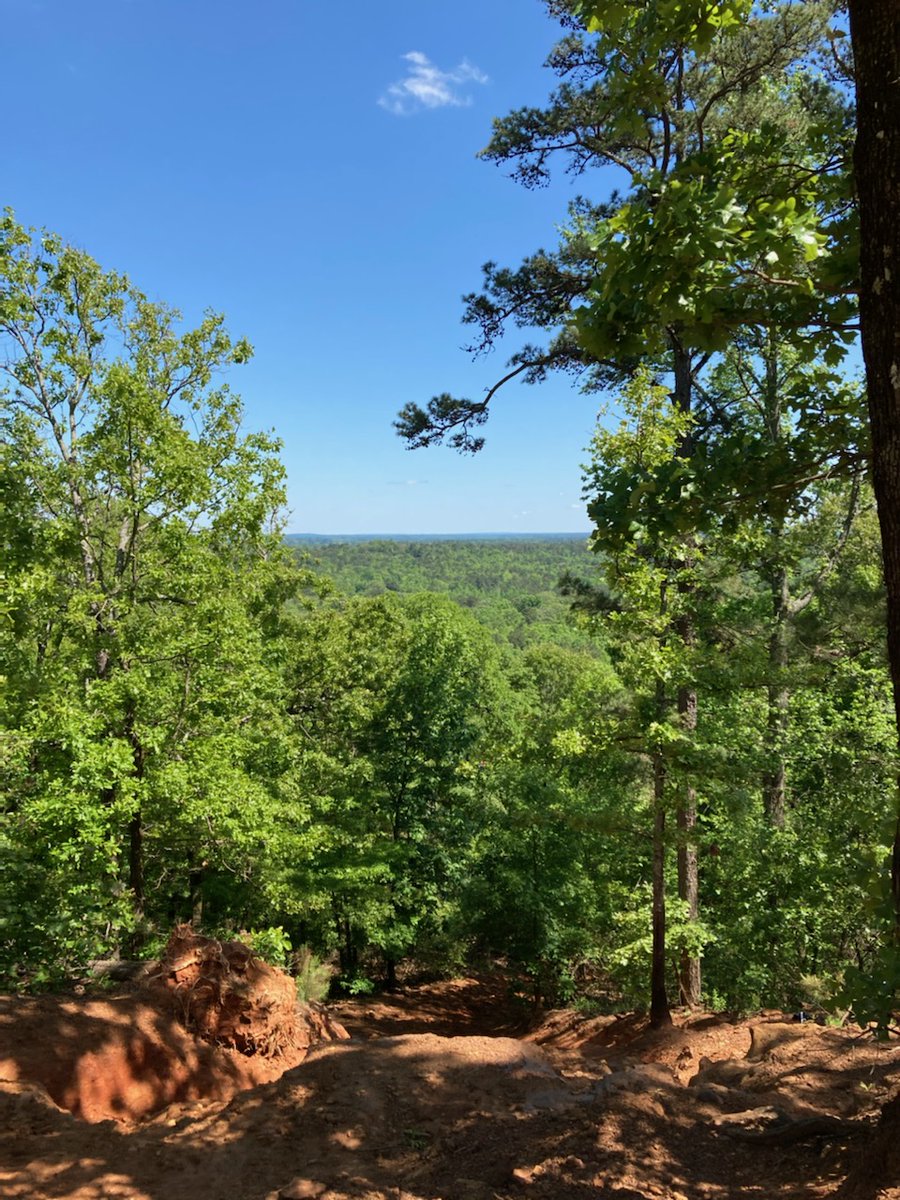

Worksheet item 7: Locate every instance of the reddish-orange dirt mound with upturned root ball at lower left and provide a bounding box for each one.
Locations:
[0,928,348,1122]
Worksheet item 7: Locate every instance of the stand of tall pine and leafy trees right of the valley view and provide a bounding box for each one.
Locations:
[388,0,895,1013]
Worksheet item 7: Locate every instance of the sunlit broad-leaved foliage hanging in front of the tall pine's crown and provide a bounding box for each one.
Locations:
[575,125,854,366]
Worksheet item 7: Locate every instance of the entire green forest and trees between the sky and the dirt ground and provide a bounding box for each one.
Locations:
[0,0,900,1021]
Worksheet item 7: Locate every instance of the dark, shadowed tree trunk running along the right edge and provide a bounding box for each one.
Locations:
[848,0,900,926]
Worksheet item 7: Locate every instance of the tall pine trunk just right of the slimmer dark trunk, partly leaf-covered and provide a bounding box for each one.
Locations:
[672,337,701,1008]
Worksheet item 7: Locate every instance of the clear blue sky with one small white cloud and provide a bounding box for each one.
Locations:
[0,0,619,533]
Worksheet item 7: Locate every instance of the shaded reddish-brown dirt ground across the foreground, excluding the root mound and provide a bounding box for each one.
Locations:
[0,979,900,1200]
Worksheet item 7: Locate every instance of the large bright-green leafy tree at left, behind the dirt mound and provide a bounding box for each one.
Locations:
[0,214,302,982]
